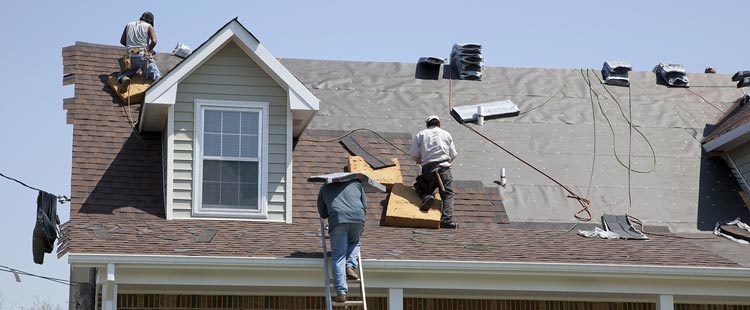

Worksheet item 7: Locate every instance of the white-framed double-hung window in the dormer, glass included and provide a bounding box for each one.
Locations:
[193,100,268,217]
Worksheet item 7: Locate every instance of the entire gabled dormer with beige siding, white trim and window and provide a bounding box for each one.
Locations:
[140,19,319,223]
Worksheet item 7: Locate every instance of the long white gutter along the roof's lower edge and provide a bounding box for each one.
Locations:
[68,253,750,282]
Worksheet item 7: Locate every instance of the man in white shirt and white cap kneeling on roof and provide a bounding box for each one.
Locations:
[409,115,458,229]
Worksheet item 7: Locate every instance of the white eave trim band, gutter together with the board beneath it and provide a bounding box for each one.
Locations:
[68,254,750,303]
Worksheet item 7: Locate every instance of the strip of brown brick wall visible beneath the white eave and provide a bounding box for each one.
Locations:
[117,294,750,310]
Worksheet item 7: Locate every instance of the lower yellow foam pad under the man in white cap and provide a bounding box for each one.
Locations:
[385,183,443,228]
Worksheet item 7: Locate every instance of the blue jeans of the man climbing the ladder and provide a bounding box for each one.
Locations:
[330,223,365,294]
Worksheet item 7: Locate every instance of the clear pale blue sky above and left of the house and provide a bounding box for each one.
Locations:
[0,0,750,310]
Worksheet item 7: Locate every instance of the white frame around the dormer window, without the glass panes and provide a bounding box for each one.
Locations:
[192,99,269,219]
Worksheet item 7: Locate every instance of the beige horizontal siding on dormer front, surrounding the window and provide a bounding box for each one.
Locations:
[172,42,289,221]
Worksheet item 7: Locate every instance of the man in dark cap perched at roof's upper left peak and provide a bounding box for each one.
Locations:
[117,11,161,93]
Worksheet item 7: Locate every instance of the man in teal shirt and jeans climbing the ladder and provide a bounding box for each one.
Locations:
[318,179,367,302]
